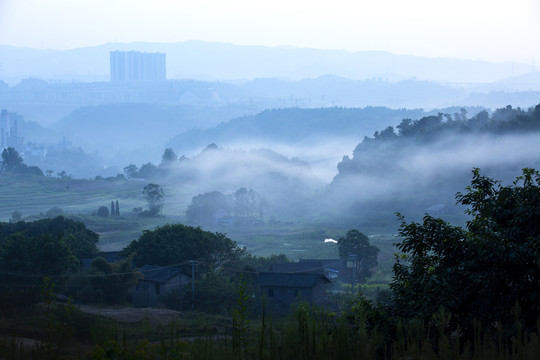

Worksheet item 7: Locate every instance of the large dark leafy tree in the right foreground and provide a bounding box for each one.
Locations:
[390,169,540,331]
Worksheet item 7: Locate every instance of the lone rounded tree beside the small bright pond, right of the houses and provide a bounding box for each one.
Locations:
[338,229,379,282]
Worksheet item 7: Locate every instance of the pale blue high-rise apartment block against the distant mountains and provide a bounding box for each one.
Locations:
[110,51,166,82]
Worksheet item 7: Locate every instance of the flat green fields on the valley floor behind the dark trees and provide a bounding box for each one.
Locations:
[0,175,395,273]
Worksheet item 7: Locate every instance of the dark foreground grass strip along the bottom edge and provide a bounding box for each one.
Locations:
[4,304,540,360]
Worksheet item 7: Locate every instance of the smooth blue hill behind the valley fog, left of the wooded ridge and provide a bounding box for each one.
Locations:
[168,106,481,152]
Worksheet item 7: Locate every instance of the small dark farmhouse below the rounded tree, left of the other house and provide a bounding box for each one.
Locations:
[131,265,191,307]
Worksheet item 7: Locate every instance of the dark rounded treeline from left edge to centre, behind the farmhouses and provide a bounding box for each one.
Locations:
[0,216,288,314]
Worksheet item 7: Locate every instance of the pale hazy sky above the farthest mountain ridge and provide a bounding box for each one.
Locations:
[0,0,540,65]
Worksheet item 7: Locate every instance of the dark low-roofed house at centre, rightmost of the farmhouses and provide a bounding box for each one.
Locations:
[258,272,330,314]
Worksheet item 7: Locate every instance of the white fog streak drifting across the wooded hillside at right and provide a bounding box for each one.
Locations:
[326,133,540,203]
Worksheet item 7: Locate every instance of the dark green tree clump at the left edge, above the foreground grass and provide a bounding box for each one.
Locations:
[0,217,98,311]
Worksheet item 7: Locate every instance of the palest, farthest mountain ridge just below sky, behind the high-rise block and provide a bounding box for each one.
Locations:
[0,41,540,83]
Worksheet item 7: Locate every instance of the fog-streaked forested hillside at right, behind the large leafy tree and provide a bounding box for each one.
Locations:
[327,105,540,225]
